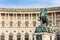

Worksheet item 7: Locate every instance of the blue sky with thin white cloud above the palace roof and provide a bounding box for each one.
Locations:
[0,0,60,8]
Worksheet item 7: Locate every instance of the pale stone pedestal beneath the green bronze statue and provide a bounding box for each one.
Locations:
[34,32,55,40]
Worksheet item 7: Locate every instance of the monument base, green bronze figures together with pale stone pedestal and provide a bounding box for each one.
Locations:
[34,24,55,40]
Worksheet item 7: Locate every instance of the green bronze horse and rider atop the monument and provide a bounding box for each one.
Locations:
[39,9,48,26]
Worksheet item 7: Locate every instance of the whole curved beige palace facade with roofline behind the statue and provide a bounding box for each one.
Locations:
[0,7,60,40]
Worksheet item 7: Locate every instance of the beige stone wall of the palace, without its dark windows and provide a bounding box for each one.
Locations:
[0,9,60,40]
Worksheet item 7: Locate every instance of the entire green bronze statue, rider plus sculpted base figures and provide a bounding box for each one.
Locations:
[35,8,53,33]
